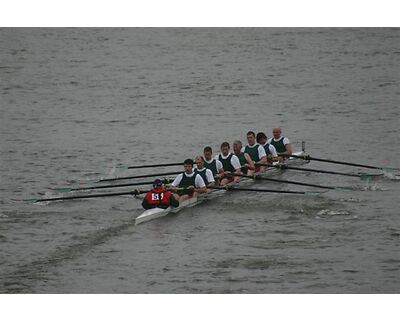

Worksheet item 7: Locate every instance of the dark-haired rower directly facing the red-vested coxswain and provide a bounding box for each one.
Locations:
[171,159,207,202]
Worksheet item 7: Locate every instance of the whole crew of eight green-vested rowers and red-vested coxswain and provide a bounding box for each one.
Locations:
[142,128,292,209]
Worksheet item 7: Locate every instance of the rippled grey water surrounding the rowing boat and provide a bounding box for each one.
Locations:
[0,28,400,293]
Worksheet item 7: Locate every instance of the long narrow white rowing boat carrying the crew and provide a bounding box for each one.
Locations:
[135,151,309,225]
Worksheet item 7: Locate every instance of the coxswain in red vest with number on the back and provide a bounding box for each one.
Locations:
[142,179,179,210]
